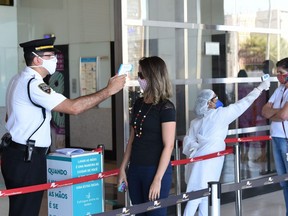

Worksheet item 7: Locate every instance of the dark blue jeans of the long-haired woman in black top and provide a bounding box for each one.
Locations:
[127,165,172,216]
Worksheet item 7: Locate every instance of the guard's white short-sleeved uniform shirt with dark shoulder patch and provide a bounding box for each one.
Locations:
[6,67,66,147]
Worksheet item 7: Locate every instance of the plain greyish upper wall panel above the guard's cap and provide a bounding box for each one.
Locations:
[18,0,114,44]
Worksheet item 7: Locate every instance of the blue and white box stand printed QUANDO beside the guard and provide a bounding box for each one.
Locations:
[47,152,104,216]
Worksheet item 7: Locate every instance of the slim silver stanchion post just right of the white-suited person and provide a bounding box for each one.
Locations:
[233,143,242,216]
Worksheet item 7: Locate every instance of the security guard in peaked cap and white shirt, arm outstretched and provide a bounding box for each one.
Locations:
[1,37,126,216]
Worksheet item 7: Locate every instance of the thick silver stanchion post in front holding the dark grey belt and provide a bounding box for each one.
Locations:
[208,182,221,216]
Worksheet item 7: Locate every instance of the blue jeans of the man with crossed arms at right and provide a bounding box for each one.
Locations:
[272,137,288,216]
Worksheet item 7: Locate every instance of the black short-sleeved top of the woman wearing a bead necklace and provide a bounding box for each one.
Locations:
[130,98,176,166]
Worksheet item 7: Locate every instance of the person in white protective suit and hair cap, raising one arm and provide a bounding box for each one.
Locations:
[183,79,270,216]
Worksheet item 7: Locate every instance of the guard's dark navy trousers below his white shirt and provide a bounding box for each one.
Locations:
[1,147,47,216]
